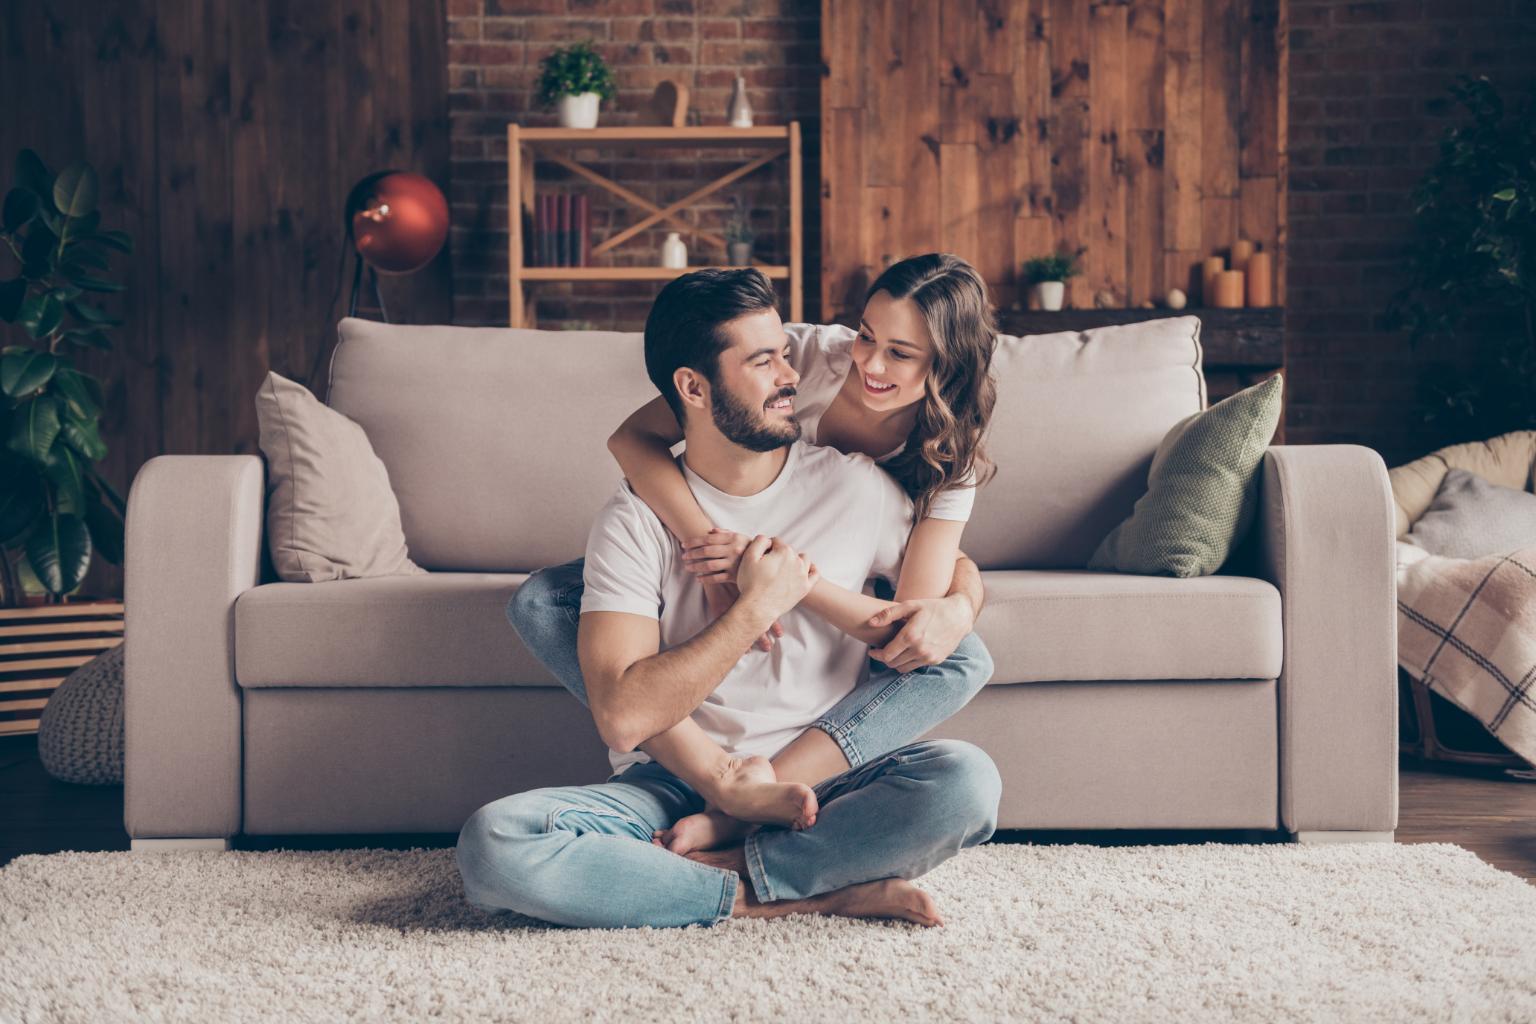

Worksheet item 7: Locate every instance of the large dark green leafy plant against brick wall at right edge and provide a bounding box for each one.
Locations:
[1387,75,1536,439]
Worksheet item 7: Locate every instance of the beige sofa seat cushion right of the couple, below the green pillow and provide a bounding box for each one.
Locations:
[977,570,1281,685]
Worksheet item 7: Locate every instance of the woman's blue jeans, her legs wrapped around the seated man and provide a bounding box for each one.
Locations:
[507,559,992,768]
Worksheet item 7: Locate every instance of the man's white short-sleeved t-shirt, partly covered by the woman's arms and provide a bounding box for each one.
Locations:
[581,442,912,774]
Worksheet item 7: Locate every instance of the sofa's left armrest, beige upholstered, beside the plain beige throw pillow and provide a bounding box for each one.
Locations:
[123,454,264,838]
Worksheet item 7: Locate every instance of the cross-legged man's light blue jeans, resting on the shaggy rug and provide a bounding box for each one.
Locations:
[455,740,1003,927]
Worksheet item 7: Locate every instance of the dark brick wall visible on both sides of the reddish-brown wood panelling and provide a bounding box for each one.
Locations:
[449,0,1536,465]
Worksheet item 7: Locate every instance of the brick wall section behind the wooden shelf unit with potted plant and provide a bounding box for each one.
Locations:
[449,0,820,330]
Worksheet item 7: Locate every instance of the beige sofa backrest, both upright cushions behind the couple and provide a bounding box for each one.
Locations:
[327,316,1206,573]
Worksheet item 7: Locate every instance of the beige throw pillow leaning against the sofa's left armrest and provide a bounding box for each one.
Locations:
[257,373,425,583]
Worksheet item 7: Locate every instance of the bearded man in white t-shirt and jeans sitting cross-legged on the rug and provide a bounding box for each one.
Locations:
[456,270,1001,927]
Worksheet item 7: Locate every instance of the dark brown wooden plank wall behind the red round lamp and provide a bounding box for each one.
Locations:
[0,0,452,594]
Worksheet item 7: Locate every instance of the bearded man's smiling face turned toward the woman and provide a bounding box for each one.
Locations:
[710,309,800,451]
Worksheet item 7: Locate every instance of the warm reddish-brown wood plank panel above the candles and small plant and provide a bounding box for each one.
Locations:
[822,0,1286,321]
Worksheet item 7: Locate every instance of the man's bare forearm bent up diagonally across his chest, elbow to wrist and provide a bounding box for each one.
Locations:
[608,600,774,752]
